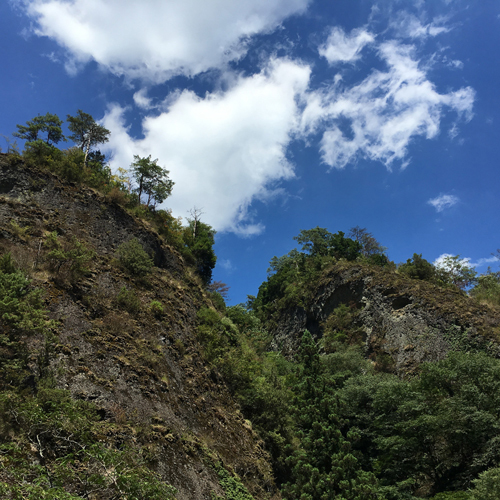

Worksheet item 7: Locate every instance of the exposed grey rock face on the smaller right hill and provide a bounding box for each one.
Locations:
[272,262,500,375]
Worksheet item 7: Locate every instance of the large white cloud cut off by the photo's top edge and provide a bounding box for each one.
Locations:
[21,0,310,83]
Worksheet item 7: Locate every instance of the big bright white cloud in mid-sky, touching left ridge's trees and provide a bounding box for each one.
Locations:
[103,59,310,235]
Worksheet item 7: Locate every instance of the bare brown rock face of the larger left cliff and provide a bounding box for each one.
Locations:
[0,155,278,500]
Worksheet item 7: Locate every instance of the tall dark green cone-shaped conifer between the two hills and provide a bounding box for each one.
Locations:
[283,331,377,500]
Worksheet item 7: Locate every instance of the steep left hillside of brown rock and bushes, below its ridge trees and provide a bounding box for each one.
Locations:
[0,155,276,500]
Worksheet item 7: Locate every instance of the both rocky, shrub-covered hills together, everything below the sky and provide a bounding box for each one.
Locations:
[0,150,500,500]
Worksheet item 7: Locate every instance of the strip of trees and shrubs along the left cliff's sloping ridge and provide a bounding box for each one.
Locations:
[6,110,217,286]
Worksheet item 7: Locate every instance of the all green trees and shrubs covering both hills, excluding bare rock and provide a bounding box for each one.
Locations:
[0,110,500,500]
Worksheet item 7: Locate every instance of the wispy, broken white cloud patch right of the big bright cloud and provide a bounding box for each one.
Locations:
[302,41,474,168]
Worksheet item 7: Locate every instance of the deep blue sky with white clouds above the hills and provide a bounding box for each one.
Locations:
[0,0,500,303]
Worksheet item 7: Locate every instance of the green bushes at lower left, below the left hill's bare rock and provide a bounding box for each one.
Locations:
[0,252,175,500]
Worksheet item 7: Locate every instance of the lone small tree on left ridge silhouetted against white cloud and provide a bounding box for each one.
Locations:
[130,155,174,208]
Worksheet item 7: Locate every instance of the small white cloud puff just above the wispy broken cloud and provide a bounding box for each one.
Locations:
[319,27,375,64]
